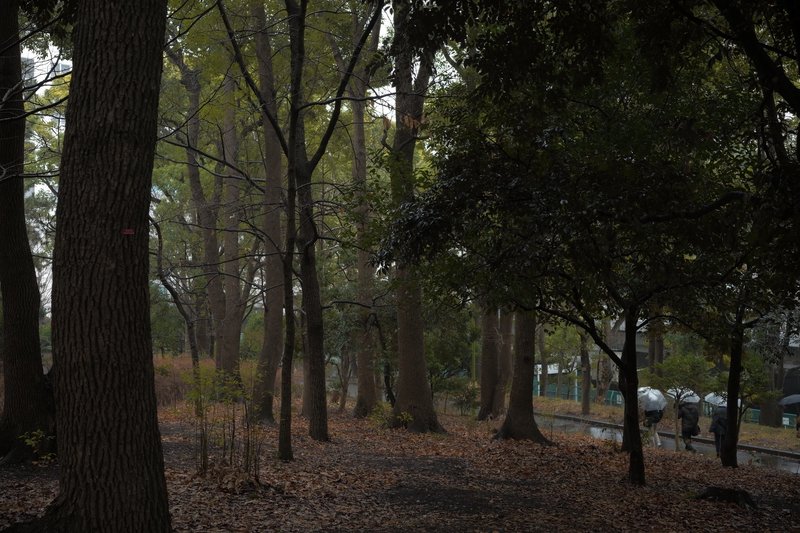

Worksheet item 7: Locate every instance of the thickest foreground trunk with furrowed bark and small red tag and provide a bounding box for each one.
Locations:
[19,0,171,533]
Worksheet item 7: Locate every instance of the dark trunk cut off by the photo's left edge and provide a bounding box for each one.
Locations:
[0,0,55,464]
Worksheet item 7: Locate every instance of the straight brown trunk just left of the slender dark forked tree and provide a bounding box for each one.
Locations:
[255,1,284,422]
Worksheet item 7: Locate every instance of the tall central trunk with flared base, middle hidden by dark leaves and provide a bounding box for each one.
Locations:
[390,0,442,432]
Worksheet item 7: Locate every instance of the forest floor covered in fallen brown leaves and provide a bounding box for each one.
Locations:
[0,402,800,532]
